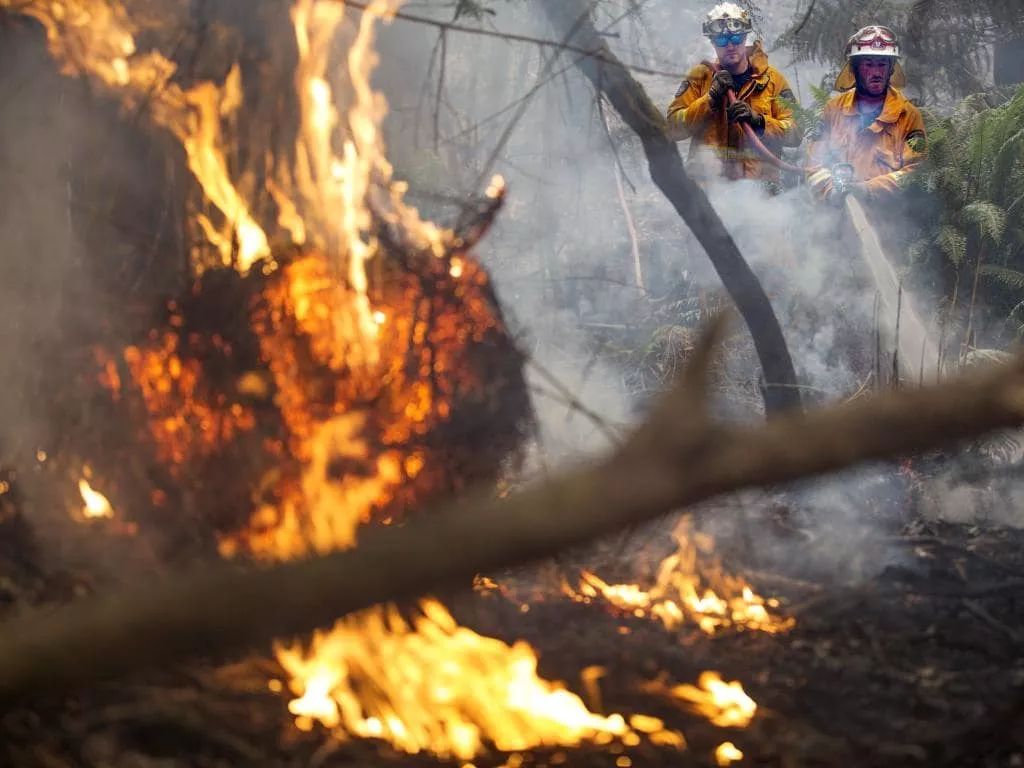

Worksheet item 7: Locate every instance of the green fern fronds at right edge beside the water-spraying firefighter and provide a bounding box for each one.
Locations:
[909,86,1024,331]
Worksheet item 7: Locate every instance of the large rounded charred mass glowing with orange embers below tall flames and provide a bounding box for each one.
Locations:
[86,236,528,558]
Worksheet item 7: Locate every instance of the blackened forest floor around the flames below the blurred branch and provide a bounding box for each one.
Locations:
[0,489,1024,768]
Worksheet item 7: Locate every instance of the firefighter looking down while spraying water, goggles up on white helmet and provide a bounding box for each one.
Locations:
[808,26,927,202]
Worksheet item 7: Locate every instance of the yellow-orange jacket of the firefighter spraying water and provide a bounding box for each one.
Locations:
[808,87,927,199]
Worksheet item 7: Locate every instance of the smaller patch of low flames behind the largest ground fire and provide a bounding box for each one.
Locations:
[565,523,795,634]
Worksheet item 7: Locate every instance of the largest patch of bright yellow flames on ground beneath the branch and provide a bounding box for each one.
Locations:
[278,600,683,760]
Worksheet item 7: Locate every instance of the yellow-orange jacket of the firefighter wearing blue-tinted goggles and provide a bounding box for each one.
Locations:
[669,42,803,181]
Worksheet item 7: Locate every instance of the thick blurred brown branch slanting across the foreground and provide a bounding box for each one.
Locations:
[0,321,1024,707]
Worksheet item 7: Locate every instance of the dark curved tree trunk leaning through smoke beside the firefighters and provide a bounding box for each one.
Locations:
[542,0,801,415]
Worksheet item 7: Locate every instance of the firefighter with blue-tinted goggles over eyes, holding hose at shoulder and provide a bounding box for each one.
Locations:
[669,3,802,181]
